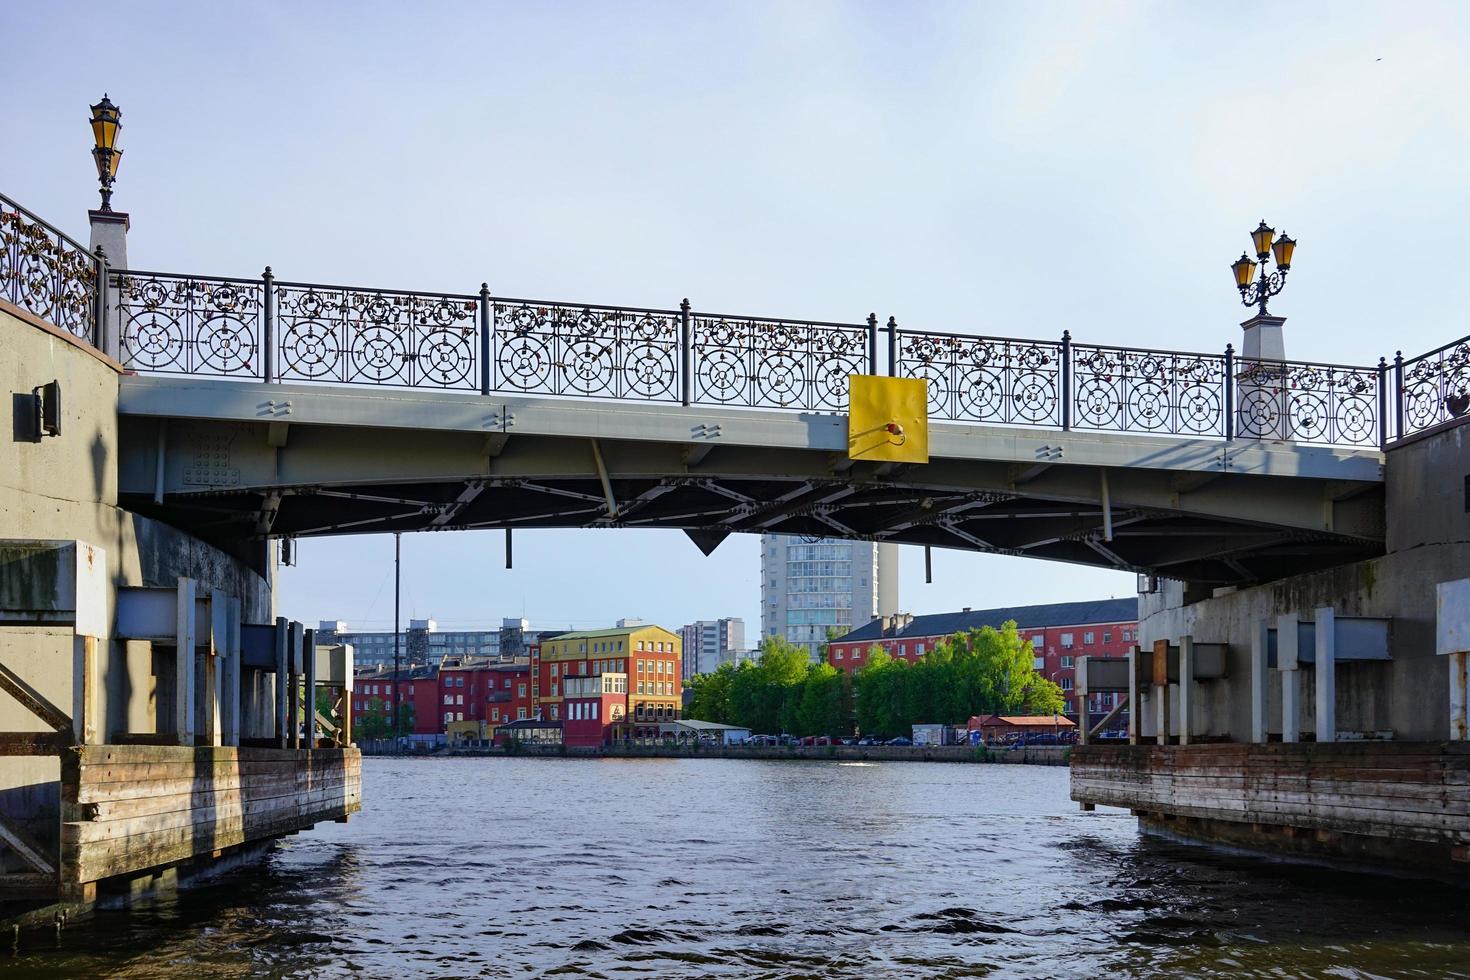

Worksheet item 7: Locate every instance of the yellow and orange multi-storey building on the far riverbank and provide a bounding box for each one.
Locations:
[531,626,684,738]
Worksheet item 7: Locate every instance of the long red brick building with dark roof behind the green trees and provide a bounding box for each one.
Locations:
[828,597,1138,724]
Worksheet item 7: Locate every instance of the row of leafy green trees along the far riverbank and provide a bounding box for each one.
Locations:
[686,621,1064,738]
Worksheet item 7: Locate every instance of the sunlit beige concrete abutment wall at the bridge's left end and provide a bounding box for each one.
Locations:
[0,300,270,871]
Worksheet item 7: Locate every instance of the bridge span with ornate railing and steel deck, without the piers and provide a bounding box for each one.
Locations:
[14,192,1470,586]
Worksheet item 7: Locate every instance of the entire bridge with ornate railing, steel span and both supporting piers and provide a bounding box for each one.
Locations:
[0,183,1470,896]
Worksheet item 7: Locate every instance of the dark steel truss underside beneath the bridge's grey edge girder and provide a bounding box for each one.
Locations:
[123,430,1382,585]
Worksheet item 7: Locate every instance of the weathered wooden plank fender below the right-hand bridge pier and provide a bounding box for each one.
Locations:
[1072,742,1470,846]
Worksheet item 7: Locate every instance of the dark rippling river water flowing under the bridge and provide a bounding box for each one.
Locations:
[0,758,1470,980]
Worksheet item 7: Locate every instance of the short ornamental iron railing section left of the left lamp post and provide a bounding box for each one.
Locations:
[0,194,103,345]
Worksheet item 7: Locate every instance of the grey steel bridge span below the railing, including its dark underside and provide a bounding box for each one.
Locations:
[119,376,1383,585]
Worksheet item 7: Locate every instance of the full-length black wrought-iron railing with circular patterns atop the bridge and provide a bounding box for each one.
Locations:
[0,189,1470,447]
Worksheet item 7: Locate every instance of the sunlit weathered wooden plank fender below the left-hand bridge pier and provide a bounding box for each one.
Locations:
[62,745,362,883]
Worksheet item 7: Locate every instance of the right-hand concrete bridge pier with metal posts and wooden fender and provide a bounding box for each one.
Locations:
[1072,419,1470,883]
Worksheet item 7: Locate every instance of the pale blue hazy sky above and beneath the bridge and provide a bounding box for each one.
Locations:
[0,0,1470,635]
